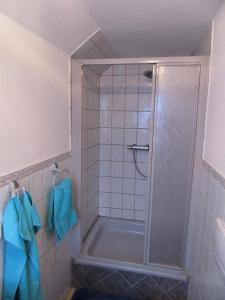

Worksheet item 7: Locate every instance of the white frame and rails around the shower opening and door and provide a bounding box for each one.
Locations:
[70,56,208,280]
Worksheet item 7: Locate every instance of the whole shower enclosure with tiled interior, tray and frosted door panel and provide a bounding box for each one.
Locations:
[77,62,200,273]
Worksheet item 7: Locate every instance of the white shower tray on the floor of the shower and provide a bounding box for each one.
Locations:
[84,217,144,264]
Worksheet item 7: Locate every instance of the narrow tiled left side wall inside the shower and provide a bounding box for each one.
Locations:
[81,67,100,236]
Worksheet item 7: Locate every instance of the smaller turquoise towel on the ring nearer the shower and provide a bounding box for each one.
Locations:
[48,178,77,241]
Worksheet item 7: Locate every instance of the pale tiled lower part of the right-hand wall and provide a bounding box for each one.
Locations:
[189,167,225,300]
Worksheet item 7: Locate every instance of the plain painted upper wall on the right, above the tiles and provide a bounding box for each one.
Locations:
[204,4,225,177]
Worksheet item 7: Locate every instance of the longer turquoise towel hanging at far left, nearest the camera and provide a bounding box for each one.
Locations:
[3,192,42,300]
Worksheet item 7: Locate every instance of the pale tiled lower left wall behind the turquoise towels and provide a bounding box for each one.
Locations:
[0,159,72,300]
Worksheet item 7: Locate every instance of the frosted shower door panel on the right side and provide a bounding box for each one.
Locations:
[148,64,200,268]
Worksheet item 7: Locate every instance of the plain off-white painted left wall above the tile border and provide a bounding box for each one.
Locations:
[0,14,70,176]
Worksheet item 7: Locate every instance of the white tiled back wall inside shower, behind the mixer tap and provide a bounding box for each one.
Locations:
[99,65,152,220]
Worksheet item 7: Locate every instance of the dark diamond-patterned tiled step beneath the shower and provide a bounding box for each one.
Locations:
[72,262,188,300]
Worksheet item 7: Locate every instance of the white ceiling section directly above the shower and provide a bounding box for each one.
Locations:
[83,0,221,57]
